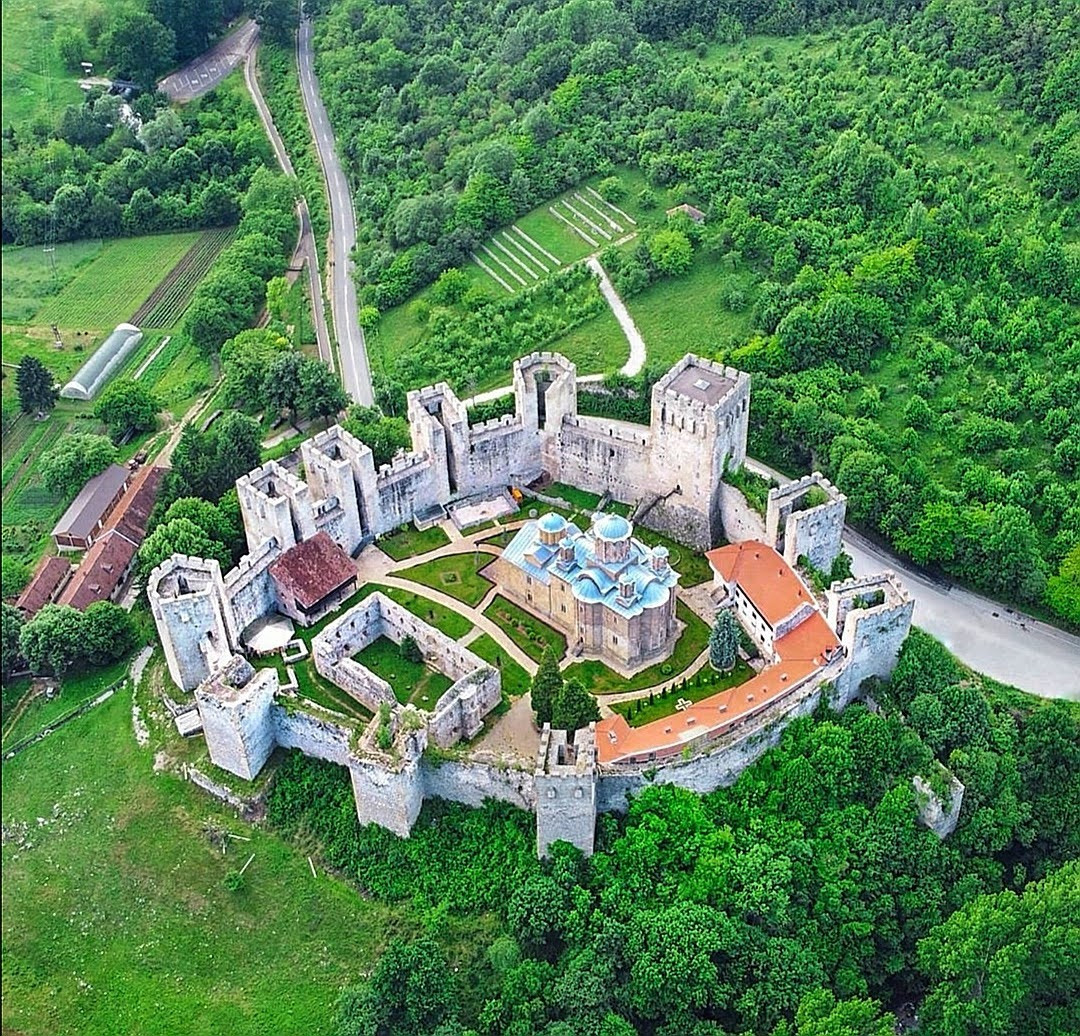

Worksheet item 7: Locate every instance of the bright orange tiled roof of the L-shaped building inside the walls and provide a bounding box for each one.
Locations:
[596,540,840,763]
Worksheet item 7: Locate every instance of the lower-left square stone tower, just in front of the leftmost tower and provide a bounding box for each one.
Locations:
[195,655,278,781]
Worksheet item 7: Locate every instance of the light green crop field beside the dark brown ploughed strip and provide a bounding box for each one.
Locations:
[32,232,200,331]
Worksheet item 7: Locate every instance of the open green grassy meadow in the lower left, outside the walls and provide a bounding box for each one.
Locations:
[2,692,505,1036]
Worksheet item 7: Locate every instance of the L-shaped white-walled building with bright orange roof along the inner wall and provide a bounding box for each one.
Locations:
[596,540,841,765]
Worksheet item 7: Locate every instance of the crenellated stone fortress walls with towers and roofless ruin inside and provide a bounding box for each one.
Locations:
[147,353,937,855]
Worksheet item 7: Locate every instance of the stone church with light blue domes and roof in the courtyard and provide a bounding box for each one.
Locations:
[494,512,678,669]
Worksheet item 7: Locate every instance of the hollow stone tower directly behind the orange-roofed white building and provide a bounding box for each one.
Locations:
[765,471,848,574]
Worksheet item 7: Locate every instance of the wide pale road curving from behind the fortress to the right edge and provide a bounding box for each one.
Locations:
[746,458,1080,701]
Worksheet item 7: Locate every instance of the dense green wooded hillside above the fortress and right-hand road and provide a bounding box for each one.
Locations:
[308,0,1080,625]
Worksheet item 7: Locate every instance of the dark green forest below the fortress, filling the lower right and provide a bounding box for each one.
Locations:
[267,631,1080,1036]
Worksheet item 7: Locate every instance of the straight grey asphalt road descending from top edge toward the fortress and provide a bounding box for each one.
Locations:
[297,18,375,406]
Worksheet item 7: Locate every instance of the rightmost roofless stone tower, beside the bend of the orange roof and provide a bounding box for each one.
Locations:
[825,571,915,709]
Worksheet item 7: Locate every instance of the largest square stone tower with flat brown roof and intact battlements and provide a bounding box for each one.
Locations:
[646,354,750,549]
